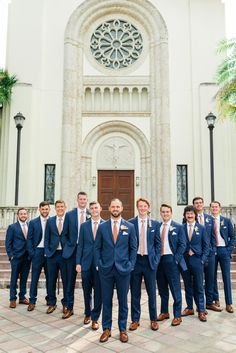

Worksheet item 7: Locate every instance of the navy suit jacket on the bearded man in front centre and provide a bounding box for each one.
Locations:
[94,219,137,275]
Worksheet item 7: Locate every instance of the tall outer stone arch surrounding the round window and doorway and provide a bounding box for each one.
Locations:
[61,0,171,211]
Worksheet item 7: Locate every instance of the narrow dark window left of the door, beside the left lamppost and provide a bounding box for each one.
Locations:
[44,164,56,204]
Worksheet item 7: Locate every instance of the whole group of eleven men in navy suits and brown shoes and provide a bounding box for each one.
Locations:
[6,192,235,342]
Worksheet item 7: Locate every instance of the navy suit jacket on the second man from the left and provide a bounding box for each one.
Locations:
[27,216,43,258]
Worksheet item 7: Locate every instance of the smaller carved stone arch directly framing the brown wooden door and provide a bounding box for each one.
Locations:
[81,120,151,198]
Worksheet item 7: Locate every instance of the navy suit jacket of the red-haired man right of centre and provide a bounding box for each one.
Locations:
[129,216,161,270]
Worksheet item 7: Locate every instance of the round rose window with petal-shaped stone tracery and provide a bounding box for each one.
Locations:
[90,20,143,70]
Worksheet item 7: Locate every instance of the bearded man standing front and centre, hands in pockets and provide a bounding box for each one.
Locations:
[95,199,137,342]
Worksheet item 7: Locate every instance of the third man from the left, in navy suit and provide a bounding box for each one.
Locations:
[44,200,67,314]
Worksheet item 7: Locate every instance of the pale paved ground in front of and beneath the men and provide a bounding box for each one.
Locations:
[0,289,236,353]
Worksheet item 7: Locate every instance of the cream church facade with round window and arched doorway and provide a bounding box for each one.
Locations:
[0,0,236,219]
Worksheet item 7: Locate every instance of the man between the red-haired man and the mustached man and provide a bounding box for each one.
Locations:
[157,204,187,326]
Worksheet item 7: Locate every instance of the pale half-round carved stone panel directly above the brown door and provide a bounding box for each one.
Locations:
[97,137,135,169]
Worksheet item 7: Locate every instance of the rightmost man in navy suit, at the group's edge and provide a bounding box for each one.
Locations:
[210,201,236,313]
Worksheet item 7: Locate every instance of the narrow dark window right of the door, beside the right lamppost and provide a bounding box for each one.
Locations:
[176,164,188,206]
